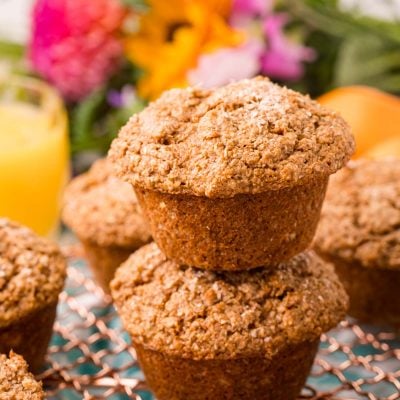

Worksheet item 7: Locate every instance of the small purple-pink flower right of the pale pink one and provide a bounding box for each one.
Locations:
[261,14,315,80]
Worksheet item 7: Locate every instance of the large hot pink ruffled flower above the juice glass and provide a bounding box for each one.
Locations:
[29,0,125,101]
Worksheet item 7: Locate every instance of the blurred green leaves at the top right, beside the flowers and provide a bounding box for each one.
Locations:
[286,0,400,95]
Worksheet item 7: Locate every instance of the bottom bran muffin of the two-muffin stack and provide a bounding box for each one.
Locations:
[111,243,347,400]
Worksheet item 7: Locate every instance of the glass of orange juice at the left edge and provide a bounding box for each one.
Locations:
[0,77,69,236]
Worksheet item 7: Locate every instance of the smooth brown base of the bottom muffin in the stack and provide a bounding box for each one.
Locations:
[135,340,319,400]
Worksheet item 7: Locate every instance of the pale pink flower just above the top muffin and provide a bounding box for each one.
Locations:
[188,40,263,88]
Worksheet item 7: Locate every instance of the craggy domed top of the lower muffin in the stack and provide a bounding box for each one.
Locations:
[111,243,347,359]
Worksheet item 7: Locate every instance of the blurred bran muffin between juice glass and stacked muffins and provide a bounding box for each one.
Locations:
[62,159,151,293]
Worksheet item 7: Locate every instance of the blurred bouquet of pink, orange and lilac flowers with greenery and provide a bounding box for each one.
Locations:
[0,0,400,162]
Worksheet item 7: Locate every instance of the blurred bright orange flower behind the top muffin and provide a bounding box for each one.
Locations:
[125,0,243,99]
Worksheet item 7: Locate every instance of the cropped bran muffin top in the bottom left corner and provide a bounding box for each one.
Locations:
[0,352,45,400]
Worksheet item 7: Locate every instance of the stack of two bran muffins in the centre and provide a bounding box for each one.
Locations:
[109,78,354,400]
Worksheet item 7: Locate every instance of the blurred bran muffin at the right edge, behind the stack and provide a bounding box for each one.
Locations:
[314,158,400,327]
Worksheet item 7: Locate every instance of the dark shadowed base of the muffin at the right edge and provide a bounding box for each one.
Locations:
[325,257,400,328]
